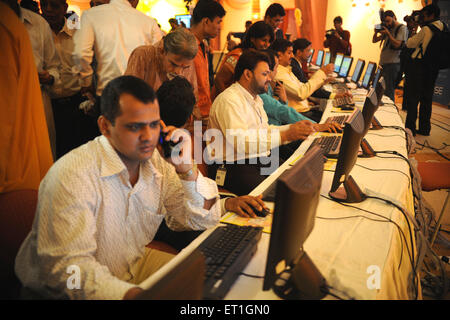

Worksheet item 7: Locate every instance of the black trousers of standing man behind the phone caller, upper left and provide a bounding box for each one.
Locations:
[52,92,98,158]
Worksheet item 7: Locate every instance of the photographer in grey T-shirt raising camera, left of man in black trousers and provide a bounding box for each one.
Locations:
[372,10,407,102]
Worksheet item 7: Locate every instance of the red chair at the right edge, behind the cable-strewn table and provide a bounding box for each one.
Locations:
[417,162,450,246]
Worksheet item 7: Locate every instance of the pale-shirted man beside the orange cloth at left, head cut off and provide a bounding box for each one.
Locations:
[20,8,60,158]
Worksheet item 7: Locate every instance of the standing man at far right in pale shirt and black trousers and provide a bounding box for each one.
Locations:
[405,4,442,136]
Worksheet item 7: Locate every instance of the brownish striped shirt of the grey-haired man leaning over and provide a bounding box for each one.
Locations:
[125,40,198,97]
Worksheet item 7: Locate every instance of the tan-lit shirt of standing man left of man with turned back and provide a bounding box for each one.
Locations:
[51,18,81,98]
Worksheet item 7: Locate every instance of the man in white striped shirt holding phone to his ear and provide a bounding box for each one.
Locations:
[15,76,221,299]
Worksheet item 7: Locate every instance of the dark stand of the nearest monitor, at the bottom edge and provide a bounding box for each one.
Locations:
[273,250,328,300]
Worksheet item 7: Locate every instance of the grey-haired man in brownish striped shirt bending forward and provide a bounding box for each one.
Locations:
[125,28,201,119]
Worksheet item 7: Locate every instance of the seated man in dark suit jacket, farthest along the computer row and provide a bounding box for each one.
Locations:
[291,38,351,99]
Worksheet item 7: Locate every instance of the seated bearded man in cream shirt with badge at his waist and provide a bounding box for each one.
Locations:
[206,50,324,195]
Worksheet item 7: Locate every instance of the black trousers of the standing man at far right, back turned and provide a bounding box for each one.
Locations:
[405,59,439,135]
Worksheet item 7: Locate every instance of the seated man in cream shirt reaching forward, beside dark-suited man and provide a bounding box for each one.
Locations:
[271,39,334,122]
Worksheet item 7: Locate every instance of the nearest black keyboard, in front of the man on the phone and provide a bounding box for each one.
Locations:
[199,224,262,299]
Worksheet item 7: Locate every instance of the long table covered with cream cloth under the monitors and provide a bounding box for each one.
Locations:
[141,90,413,300]
